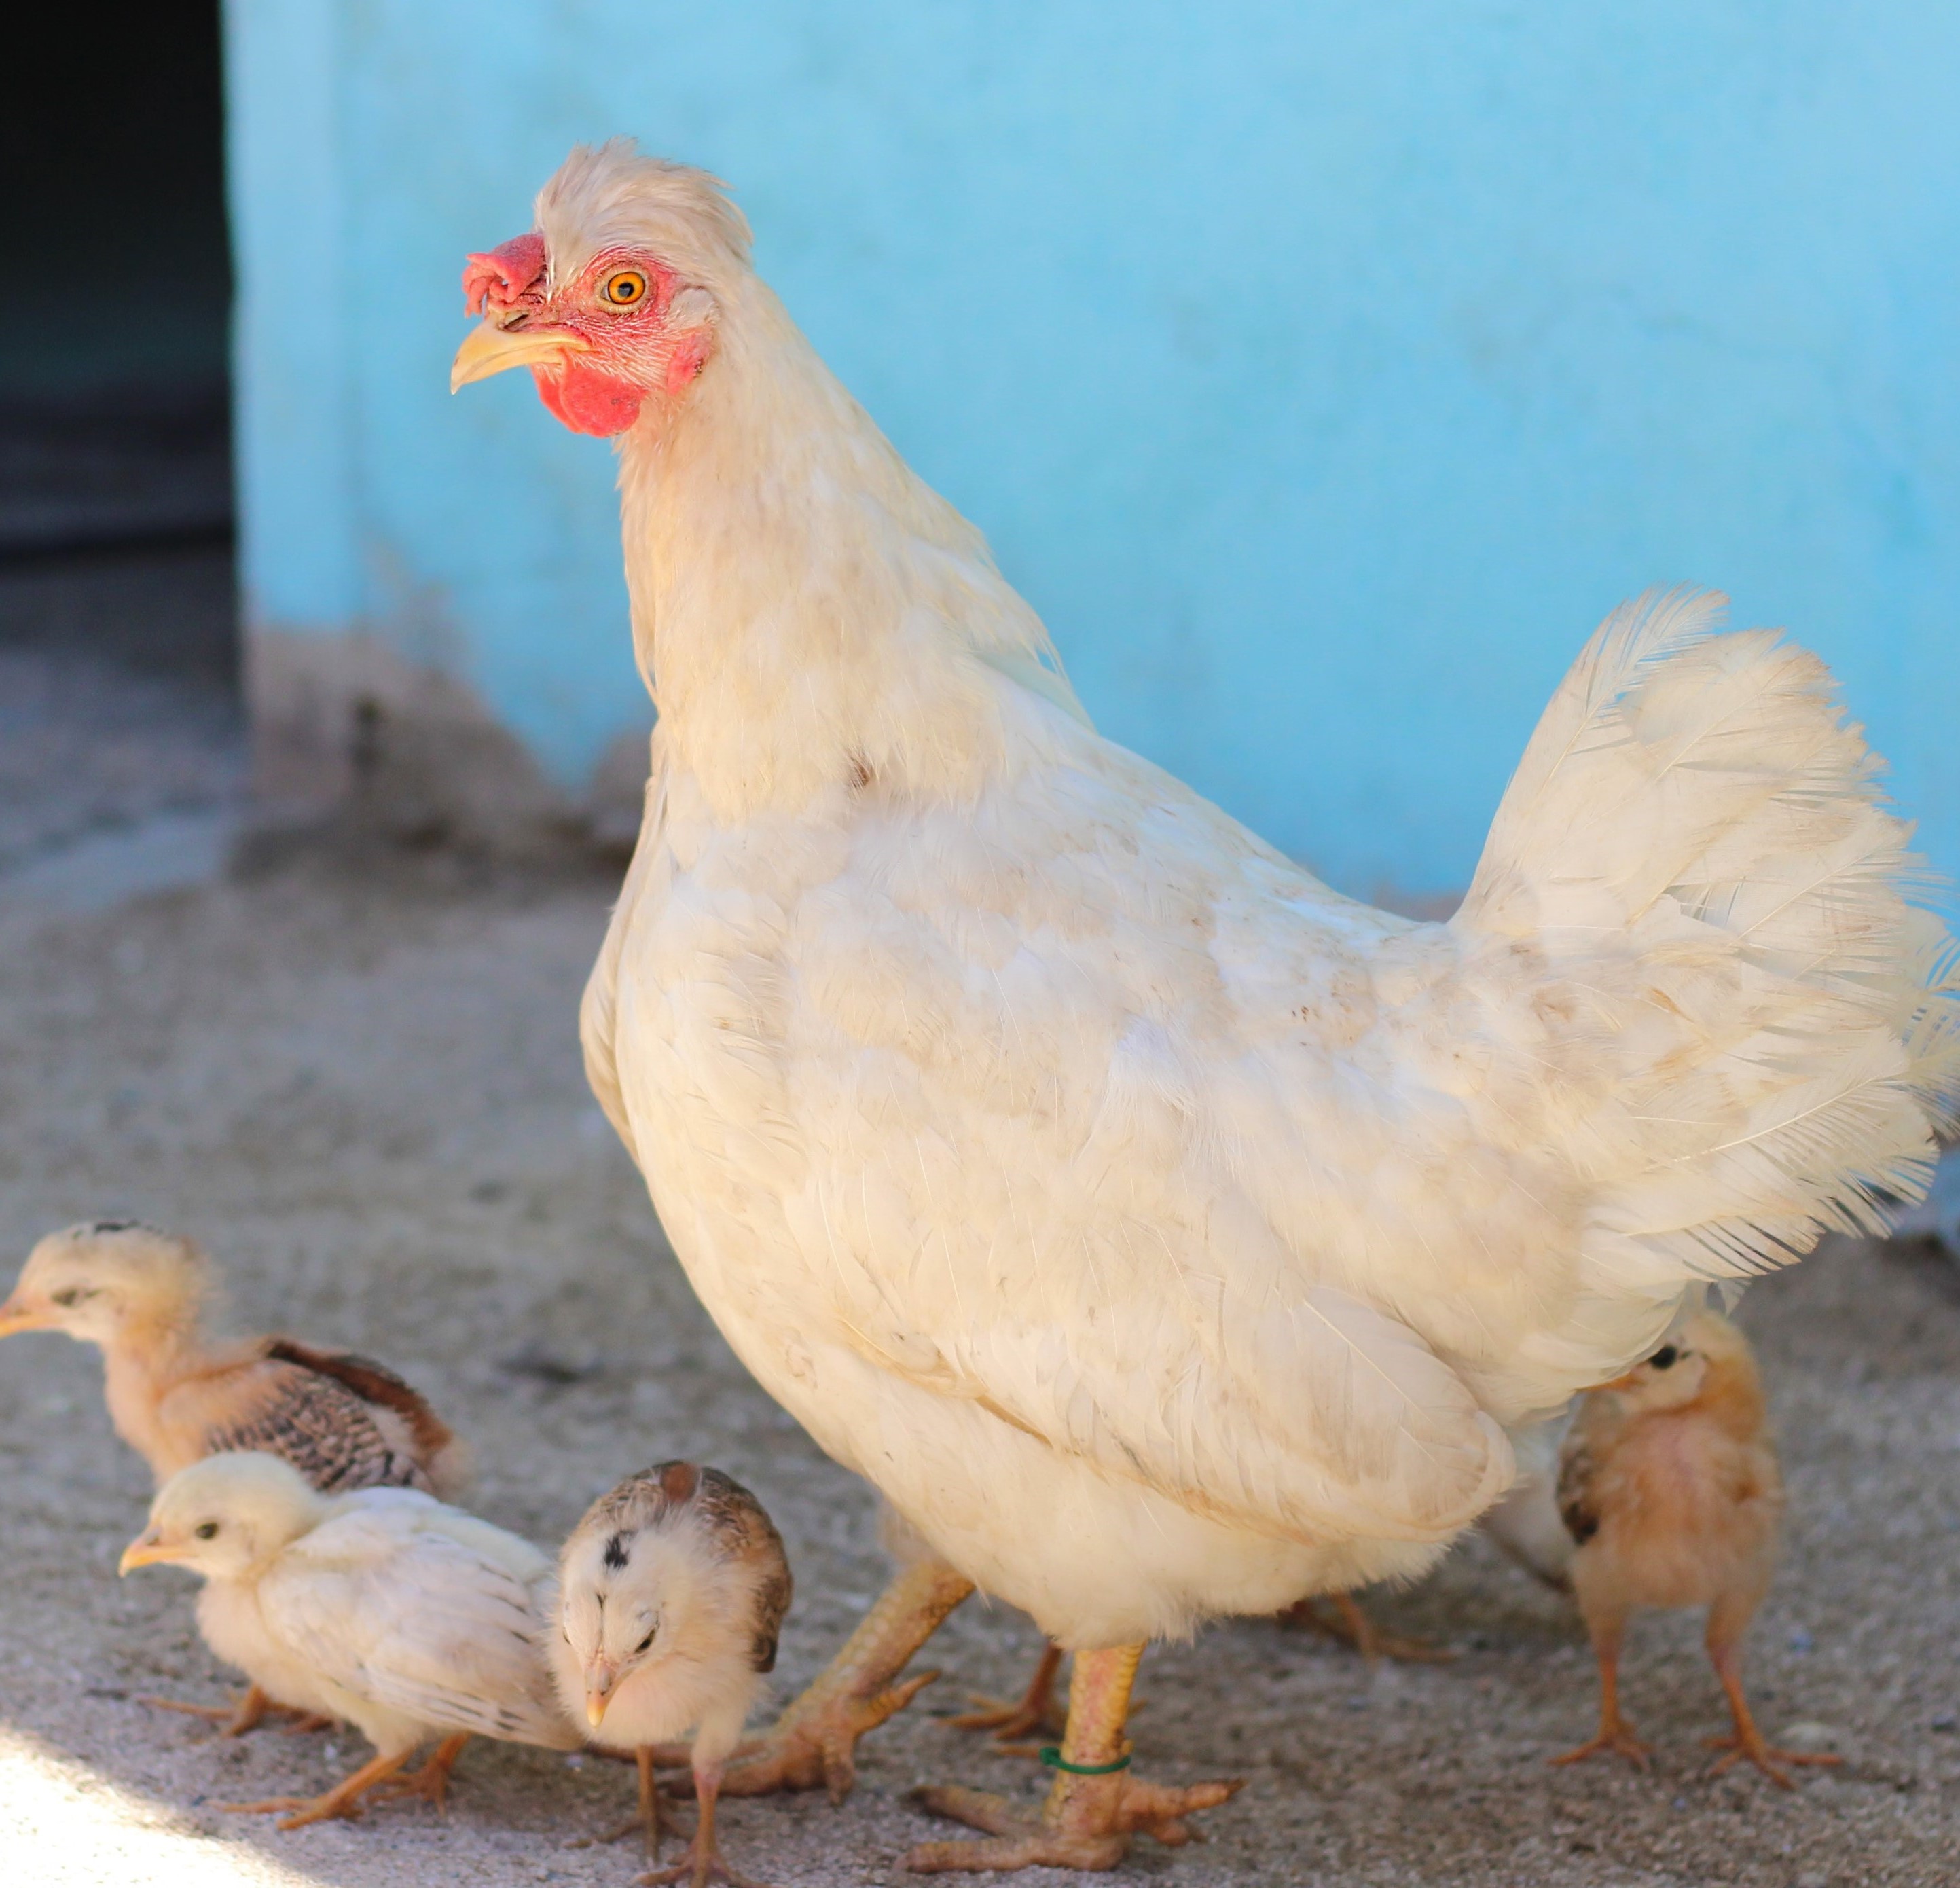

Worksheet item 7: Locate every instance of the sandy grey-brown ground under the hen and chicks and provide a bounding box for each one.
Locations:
[0,655,1960,1888]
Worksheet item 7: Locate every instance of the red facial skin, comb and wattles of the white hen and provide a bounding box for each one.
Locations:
[462,234,715,439]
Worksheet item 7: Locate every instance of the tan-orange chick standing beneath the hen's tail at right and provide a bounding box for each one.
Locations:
[1553,1311,1838,1790]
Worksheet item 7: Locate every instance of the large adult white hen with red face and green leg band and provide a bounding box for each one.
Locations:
[453,143,1954,1866]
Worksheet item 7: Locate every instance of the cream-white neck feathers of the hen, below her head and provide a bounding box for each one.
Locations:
[619,280,1086,820]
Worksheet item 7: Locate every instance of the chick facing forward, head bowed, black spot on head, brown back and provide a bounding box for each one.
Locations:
[551,1463,792,1888]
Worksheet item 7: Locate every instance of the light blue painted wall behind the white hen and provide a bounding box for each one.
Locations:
[230,0,1960,892]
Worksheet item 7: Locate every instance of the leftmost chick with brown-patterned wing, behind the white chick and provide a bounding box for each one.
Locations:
[0,1220,467,1737]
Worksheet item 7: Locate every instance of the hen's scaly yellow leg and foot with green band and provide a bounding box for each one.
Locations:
[905,1645,1245,1874]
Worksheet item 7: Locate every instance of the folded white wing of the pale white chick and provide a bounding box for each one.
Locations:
[259,1488,582,1749]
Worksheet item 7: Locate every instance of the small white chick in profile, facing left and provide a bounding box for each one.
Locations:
[122,1453,582,1829]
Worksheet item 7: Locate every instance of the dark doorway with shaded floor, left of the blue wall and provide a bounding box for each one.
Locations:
[0,0,245,886]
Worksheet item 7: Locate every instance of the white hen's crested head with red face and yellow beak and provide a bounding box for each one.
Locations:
[449,137,748,437]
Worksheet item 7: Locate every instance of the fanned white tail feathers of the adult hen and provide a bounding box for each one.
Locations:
[1453,590,1960,1325]
